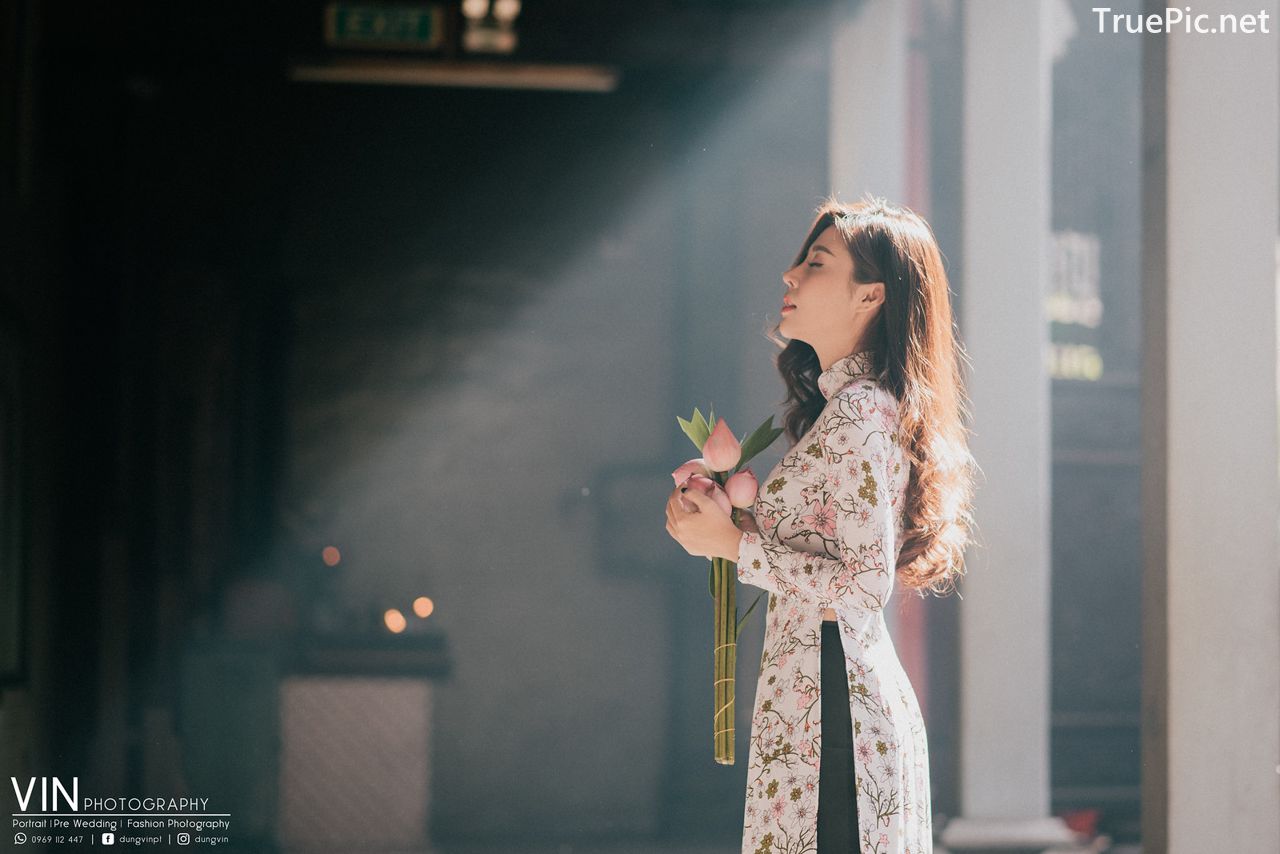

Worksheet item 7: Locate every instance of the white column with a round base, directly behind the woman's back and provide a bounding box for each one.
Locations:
[942,0,1070,850]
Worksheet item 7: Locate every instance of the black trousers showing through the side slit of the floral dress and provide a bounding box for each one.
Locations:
[818,620,859,854]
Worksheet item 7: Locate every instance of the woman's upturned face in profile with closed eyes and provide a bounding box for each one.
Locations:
[778,225,874,365]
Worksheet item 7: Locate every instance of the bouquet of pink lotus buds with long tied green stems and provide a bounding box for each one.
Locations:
[671,408,782,766]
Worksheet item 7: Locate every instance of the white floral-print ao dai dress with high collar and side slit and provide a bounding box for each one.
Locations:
[737,351,933,854]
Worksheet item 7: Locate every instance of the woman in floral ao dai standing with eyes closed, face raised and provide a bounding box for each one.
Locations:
[667,198,975,854]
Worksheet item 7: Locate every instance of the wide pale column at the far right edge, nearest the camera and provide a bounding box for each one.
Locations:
[1143,0,1280,854]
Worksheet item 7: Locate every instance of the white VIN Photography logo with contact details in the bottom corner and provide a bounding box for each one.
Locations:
[9,777,232,850]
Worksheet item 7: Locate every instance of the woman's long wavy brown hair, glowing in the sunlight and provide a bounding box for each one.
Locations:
[768,195,978,597]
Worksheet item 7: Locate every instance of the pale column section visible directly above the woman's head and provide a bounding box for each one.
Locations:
[829,0,909,204]
